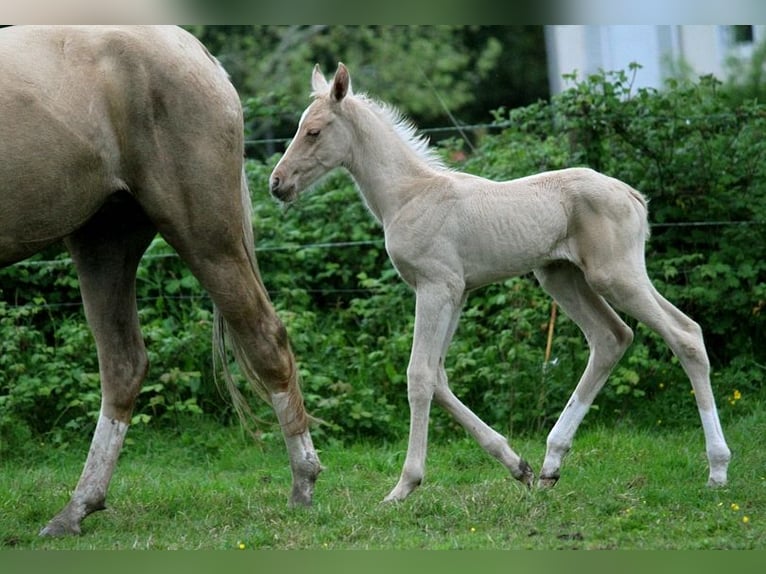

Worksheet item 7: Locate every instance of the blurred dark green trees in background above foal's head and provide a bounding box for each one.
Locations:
[187,25,548,159]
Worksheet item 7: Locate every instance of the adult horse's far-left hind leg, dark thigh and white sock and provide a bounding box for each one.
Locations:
[40,196,155,536]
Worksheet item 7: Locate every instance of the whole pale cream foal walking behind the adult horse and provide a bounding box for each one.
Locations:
[270,64,731,500]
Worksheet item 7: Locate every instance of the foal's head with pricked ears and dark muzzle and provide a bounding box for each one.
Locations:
[269,64,352,201]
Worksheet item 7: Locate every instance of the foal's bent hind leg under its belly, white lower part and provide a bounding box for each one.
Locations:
[535,262,633,487]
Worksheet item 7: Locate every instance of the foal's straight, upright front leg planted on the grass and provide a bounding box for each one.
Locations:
[384,284,461,502]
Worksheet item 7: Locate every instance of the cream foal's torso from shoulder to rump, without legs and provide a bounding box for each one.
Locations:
[386,168,648,289]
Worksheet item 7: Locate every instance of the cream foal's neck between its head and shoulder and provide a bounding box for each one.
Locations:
[347,101,437,224]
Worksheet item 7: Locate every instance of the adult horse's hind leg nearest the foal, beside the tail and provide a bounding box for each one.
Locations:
[165,204,322,506]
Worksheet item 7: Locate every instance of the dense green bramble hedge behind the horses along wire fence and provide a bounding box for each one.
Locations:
[0,64,766,450]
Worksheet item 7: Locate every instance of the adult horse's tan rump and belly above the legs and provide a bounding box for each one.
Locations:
[0,26,242,264]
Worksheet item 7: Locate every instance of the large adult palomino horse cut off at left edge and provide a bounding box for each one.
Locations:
[0,26,321,536]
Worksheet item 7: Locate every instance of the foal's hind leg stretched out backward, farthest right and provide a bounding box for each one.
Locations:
[595,267,731,486]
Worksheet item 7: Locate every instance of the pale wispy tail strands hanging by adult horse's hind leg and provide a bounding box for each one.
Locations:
[213,166,308,435]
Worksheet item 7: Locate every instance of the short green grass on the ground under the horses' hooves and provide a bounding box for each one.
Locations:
[0,411,766,550]
